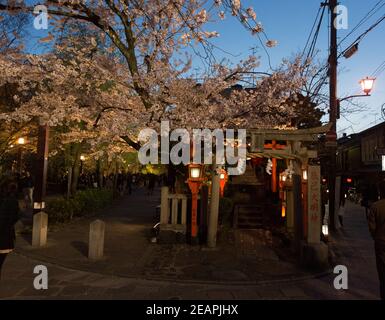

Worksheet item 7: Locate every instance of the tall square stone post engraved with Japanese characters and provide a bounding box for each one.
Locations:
[307,166,321,244]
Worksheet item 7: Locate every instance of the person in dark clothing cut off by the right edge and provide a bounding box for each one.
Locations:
[368,181,385,300]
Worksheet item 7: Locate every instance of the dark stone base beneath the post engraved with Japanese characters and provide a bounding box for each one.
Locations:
[300,242,329,270]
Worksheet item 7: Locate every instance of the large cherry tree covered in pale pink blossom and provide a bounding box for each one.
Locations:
[0,0,320,149]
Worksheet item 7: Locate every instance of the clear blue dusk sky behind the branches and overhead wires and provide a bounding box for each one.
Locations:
[30,0,385,135]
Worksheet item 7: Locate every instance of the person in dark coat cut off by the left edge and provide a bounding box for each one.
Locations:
[0,183,19,277]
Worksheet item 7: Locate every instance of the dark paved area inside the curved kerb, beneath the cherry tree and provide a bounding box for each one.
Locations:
[13,189,312,284]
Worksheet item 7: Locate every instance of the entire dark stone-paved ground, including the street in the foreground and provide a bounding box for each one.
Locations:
[0,193,379,300]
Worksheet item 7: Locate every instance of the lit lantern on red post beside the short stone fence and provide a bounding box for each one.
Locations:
[187,163,204,243]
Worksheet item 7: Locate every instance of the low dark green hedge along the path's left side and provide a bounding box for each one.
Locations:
[46,189,113,223]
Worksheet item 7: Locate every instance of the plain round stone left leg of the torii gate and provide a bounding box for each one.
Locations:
[207,171,220,248]
